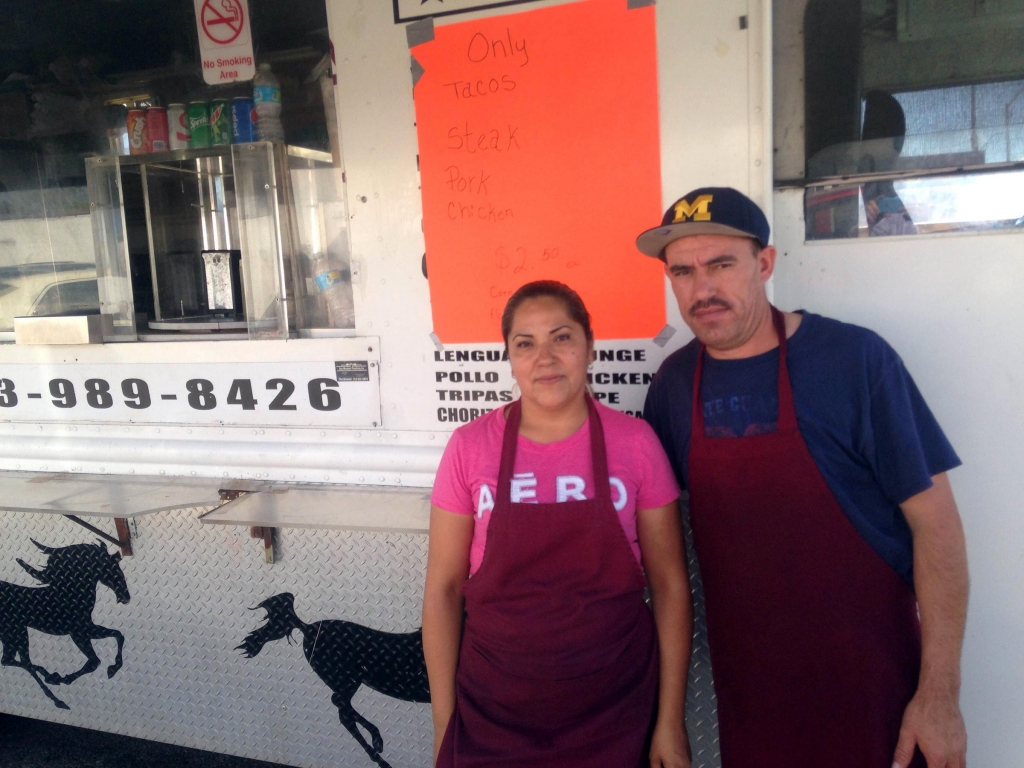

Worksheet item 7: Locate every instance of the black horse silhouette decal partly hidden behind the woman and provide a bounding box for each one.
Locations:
[238,592,430,768]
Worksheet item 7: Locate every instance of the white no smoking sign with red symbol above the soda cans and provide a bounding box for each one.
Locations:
[195,0,256,85]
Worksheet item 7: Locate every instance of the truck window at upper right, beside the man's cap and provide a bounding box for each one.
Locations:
[776,0,1024,240]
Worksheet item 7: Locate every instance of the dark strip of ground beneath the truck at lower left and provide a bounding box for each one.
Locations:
[0,715,288,768]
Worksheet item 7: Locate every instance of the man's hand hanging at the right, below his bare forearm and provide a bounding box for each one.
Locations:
[893,689,967,768]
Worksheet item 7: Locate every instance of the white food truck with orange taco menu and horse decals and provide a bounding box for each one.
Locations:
[0,0,1024,768]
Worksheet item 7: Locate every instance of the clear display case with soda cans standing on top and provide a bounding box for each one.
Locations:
[86,141,355,341]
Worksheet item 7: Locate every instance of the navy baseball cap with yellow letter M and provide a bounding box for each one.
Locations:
[637,186,771,258]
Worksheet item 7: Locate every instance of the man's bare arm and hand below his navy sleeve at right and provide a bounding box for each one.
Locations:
[893,472,968,768]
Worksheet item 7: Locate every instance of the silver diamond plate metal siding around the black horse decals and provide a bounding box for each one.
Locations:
[0,509,719,768]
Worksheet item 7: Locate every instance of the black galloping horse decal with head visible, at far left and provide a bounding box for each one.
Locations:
[0,540,131,710]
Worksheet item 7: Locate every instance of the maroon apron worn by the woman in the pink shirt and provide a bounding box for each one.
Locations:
[437,397,658,768]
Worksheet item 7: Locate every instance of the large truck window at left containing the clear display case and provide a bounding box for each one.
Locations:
[0,0,355,341]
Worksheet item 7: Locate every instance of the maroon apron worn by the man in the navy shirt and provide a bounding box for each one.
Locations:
[689,308,925,768]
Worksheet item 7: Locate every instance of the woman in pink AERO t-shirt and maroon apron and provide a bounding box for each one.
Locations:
[423,281,692,768]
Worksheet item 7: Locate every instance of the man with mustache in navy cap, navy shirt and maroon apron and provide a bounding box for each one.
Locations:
[637,187,968,768]
